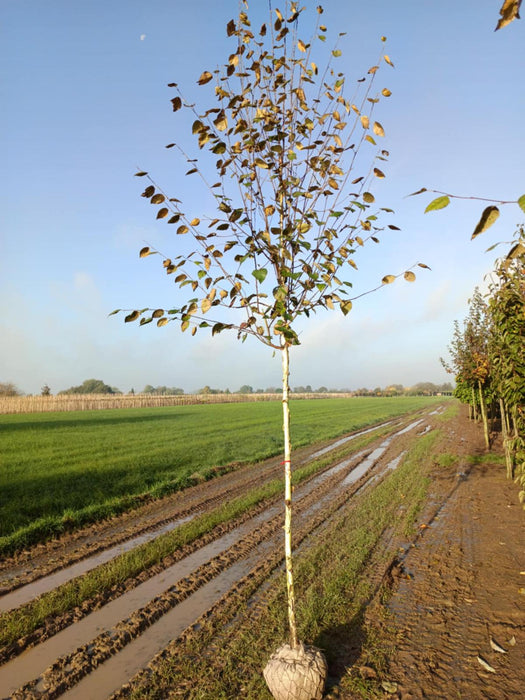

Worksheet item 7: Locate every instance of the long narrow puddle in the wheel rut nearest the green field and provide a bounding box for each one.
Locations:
[0,515,195,612]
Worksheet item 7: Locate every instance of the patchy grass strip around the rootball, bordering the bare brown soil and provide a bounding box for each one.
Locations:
[123,432,438,700]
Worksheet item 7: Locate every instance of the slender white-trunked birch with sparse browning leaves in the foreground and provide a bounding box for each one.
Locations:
[113,2,427,698]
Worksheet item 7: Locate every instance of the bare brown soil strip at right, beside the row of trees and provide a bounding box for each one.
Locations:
[344,404,525,700]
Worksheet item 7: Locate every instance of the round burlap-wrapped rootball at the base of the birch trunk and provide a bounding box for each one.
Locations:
[263,643,328,700]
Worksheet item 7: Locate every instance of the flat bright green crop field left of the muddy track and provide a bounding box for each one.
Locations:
[0,397,442,554]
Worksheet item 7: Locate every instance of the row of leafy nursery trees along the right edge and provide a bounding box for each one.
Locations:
[443,226,525,503]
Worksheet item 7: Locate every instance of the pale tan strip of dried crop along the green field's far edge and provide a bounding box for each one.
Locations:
[0,394,351,414]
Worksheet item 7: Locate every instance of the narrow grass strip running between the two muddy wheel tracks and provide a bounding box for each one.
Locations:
[0,428,391,648]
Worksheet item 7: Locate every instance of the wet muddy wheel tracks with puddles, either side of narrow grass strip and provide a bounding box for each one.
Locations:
[0,414,450,700]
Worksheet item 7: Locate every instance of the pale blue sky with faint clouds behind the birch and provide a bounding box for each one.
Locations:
[0,0,525,393]
